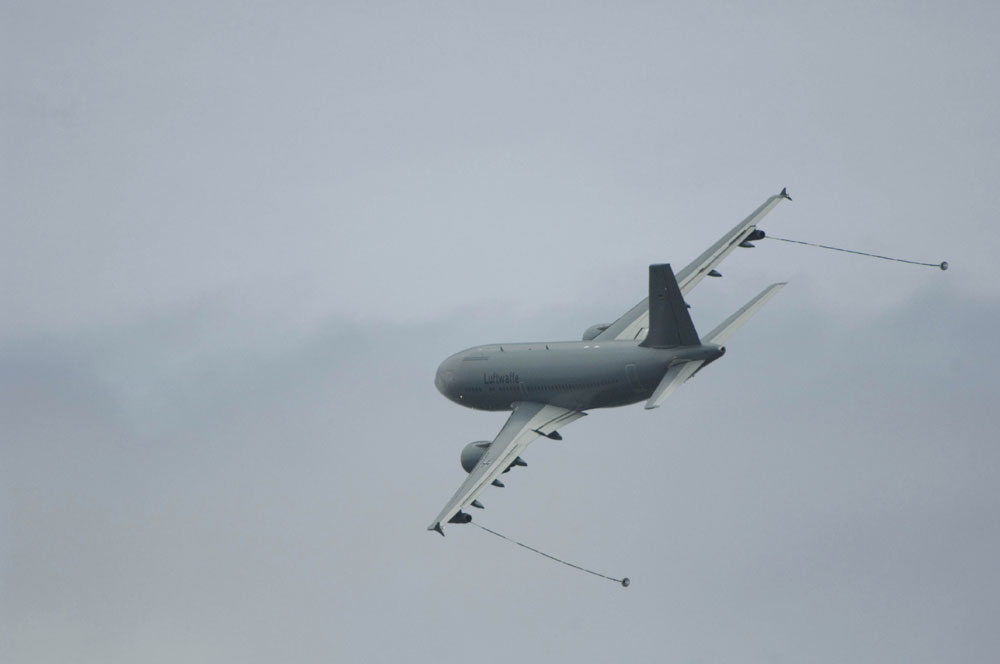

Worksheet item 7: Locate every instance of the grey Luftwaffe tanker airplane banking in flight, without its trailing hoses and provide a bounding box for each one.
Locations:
[427,189,792,536]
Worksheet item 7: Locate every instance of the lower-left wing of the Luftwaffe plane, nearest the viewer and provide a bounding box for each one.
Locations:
[427,401,586,535]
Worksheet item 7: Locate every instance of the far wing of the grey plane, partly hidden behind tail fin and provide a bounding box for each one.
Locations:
[594,189,792,341]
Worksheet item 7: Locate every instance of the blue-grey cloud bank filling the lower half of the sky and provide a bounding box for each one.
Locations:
[2,276,1000,661]
